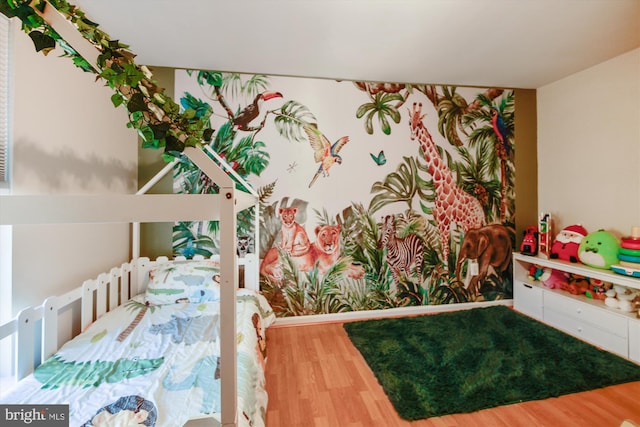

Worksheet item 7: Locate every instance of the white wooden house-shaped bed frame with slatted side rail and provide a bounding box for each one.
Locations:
[0,1,259,427]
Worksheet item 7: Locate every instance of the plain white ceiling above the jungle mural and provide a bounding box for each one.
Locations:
[72,0,640,88]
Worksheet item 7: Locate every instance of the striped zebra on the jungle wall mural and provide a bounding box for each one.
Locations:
[381,215,424,284]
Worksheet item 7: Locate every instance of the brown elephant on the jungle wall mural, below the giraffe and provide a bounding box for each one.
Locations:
[456,224,512,295]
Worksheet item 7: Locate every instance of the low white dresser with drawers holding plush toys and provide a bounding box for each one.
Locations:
[513,253,640,363]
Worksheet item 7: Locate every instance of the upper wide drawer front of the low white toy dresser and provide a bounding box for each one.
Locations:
[544,292,628,338]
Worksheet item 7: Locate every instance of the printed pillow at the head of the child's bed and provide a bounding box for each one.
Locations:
[145,260,220,305]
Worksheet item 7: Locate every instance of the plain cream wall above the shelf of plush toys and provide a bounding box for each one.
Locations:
[537,49,640,236]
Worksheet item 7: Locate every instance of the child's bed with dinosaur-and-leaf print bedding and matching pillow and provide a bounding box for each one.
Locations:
[0,256,275,427]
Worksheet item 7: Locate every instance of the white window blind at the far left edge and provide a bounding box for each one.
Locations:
[0,15,9,187]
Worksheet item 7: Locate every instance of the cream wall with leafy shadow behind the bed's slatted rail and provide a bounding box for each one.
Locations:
[5,19,138,313]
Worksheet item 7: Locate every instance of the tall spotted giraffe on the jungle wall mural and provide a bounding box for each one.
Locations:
[409,102,485,265]
